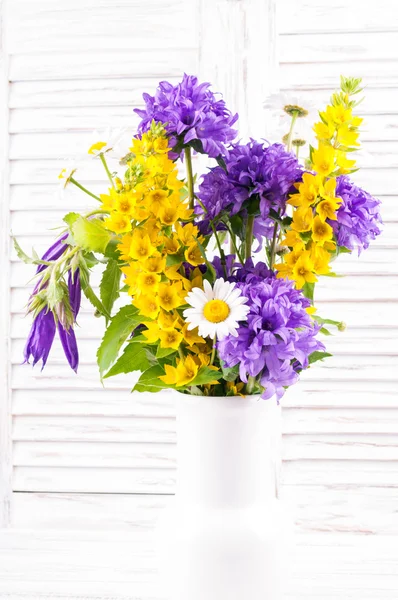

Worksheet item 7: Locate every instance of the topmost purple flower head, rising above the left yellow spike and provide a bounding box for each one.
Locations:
[135,74,238,158]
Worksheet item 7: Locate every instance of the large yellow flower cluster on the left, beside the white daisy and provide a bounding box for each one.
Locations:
[100,126,211,386]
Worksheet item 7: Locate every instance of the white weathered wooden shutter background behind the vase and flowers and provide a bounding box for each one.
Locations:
[0,0,398,600]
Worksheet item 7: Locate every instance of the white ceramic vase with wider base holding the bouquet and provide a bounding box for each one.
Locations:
[157,393,292,600]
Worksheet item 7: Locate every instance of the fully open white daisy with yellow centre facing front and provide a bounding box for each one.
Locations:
[184,279,250,339]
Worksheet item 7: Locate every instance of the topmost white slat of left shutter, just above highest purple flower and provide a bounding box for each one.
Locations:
[9,47,198,81]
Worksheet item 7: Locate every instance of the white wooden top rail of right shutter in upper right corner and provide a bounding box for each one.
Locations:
[278,0,398,37]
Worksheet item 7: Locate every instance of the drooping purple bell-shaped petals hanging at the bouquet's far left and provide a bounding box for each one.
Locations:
[24,235,81,371]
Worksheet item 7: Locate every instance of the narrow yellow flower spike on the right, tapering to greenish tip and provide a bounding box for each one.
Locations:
[275,84,362,289]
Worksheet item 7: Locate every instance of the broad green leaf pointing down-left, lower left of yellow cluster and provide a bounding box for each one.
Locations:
[97,304,143,377]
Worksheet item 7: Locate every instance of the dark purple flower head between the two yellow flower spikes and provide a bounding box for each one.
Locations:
[196,140,303,236]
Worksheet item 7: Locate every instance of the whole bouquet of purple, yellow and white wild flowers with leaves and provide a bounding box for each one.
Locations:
[16,75,381,399]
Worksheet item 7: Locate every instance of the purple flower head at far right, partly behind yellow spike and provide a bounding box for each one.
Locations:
[329,175,382,254]
